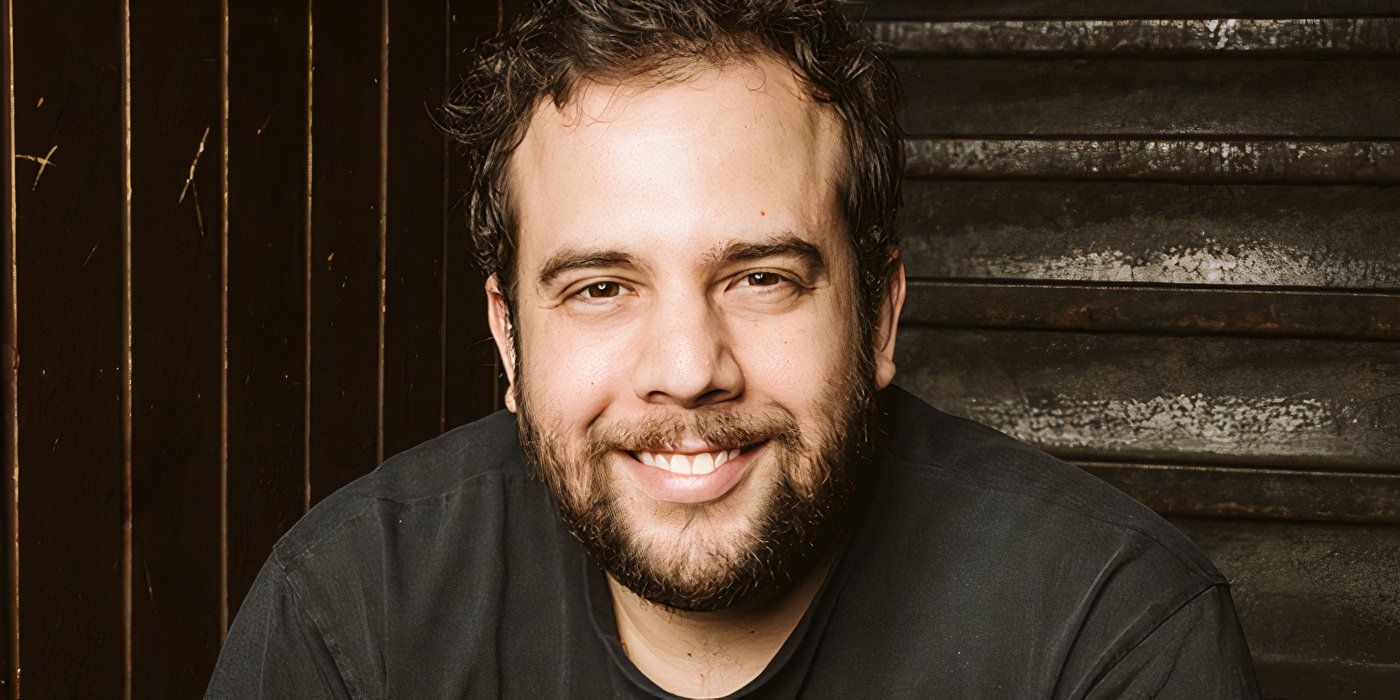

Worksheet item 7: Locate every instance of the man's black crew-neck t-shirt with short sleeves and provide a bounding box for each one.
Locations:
[209,388,1259,699]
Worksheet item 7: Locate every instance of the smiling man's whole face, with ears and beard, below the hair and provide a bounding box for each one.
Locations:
[489,60,892,610]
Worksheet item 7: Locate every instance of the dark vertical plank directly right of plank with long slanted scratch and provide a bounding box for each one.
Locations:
[227,0,309,617]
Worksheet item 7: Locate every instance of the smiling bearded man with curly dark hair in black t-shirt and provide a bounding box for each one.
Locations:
[209,0,1257,697]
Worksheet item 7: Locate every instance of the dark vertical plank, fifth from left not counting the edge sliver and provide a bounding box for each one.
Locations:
[384,1,448,455]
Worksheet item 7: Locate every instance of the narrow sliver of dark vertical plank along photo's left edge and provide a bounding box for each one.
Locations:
[0,0,20,699]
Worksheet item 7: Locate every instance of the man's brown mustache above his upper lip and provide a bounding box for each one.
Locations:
[588,409,801,458]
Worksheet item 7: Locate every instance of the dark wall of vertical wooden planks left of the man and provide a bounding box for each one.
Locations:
[3,0,504,697]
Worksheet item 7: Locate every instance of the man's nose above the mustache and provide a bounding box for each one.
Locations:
[633,295,743,409]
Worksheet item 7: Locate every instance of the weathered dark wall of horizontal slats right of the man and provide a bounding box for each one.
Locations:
[857,0,1400,697]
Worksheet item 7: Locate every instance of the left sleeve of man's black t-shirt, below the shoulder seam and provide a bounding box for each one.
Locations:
[204,560,350,699]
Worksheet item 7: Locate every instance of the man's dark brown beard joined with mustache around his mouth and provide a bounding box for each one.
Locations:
[515,351,874,612]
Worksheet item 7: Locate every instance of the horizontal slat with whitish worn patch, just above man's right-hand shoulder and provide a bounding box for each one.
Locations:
[896,326,1400,472]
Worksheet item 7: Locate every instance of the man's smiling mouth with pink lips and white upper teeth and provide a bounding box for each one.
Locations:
[622,441,767,504]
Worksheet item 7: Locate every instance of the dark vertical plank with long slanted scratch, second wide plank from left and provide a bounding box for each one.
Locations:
[130,0,223,697]
